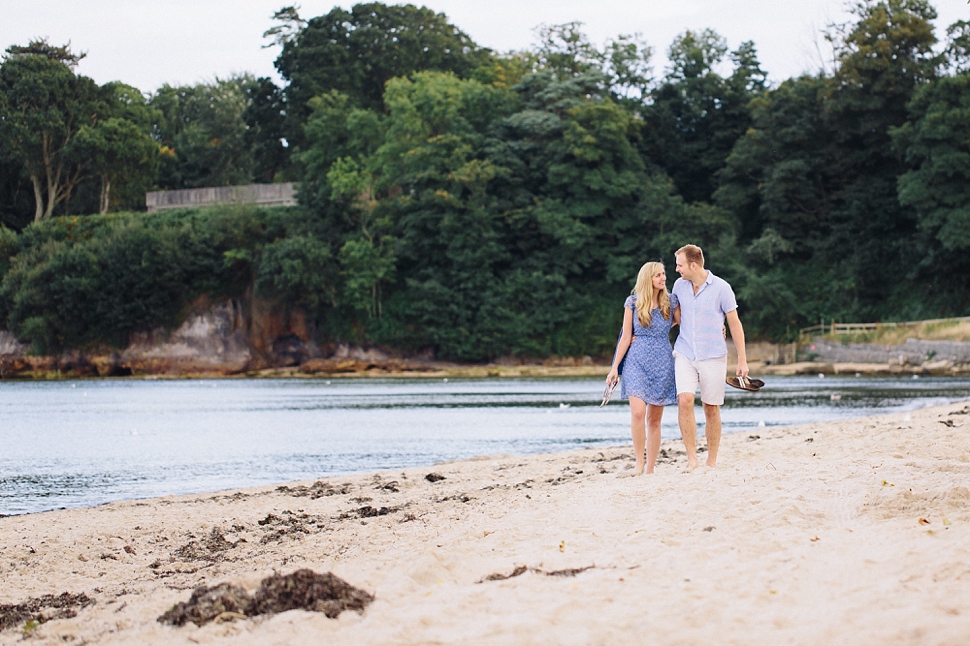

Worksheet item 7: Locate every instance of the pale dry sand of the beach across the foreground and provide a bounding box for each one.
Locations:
[0,404,970,645]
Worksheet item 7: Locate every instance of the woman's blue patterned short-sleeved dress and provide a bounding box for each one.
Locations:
[620,294,679,406]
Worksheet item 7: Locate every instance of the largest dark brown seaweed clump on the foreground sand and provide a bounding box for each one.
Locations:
[158,569,374,626]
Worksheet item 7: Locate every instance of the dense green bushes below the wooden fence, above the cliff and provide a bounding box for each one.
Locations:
[0,209,324,352]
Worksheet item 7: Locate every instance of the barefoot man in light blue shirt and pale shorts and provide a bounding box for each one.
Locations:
[673,245,748,471]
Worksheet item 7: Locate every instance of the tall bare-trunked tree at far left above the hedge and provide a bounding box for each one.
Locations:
[0,40,107,221]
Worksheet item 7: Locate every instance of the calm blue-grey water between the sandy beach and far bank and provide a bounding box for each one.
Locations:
[0,377,970,514]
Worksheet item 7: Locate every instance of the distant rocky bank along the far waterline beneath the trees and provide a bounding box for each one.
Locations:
[0,300,970,379]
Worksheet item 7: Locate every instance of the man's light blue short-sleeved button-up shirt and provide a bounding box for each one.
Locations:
[671,271,738,361]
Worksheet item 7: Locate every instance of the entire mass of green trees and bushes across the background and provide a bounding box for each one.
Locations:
[0,0,970,360]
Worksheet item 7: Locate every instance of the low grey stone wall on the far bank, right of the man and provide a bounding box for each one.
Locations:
[802,338,970,366]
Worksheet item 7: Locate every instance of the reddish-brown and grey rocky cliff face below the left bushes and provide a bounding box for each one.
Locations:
[0,300,321,377]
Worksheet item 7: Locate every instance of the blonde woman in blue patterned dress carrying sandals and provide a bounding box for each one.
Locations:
[606,262,680,476]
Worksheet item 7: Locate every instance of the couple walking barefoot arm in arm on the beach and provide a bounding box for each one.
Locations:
[606,245,748,475]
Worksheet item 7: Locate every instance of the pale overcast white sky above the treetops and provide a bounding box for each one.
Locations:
[0,0,970,91]
